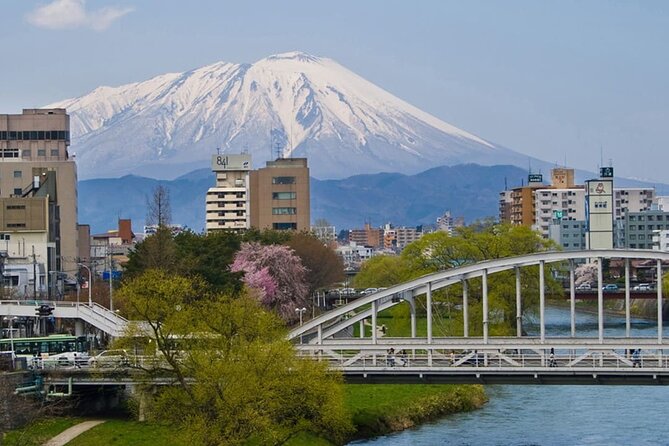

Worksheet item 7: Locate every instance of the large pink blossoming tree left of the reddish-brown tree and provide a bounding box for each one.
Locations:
[230,242,309,322]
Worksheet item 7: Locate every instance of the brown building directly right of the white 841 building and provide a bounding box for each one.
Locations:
[250,158,311,231]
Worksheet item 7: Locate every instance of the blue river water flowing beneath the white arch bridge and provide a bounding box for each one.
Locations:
[353,308,669,446]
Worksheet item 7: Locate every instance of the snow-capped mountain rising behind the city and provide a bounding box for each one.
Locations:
[47,52,527,178]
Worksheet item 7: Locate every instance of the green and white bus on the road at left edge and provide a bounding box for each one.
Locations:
[0,334,89,359]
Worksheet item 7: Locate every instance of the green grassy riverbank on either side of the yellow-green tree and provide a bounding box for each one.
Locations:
[0,384,486,446]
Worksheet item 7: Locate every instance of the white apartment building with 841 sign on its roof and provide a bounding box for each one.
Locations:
[205,154,251,233]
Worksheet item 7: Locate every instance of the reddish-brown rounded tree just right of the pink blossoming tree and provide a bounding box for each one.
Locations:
[288,232,344,293]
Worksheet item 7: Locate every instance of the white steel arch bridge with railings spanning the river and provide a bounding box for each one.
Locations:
[289,249,669,384]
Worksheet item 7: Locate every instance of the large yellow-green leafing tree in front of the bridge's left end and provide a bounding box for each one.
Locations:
[120,271,351,446]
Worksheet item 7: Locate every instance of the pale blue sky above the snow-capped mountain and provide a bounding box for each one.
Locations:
[0,0,669,183]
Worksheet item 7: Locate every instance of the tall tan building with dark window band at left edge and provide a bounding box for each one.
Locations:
[0,109,79,290]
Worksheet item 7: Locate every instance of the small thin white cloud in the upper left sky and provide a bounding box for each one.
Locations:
[26,0,133,31]
